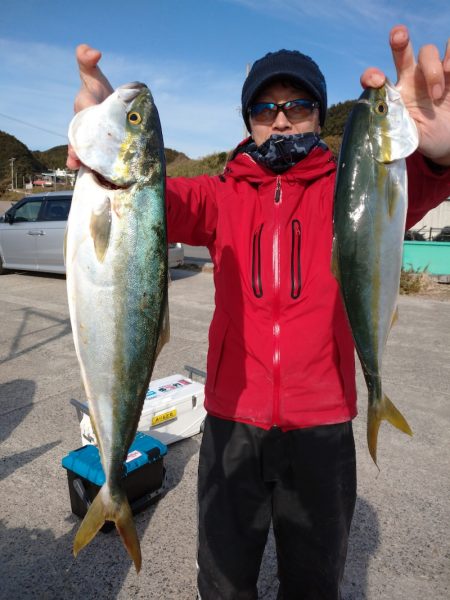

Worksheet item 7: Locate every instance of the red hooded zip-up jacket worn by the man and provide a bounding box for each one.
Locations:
[167,143,450,430]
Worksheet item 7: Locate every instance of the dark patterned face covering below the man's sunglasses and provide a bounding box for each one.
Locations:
[245,132,327,173]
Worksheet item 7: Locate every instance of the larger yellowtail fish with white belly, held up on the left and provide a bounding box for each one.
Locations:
[66,83,168,571]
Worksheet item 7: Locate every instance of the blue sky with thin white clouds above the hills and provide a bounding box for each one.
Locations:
[0,0,450,158]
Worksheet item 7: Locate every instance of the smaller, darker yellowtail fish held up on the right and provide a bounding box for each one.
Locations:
[332,81,418,464]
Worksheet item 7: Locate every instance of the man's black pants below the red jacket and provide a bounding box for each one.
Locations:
[198,416,356,600]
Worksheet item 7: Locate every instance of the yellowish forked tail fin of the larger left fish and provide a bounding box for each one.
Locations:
[73,484,142,573]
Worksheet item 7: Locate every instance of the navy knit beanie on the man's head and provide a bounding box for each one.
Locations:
[242,50,327,131]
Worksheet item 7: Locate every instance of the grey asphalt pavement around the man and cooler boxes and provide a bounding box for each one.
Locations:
[0,270,450,600]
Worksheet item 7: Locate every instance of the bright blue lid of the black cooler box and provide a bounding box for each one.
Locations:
[62,431,167,486]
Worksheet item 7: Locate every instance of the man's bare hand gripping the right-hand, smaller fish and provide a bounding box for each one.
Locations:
[361,25,450,166]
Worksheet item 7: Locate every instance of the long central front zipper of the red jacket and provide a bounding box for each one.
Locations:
[272,176,282,427]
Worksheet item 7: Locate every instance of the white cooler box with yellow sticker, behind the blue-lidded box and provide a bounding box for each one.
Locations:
[71,367,206,445]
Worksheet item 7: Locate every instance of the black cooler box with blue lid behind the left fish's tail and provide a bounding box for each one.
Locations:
[62,432,167,532]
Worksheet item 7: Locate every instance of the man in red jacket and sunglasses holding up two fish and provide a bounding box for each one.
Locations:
[68,26,450,600]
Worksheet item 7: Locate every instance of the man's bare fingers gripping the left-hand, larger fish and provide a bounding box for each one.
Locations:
[67,44,113,169]
